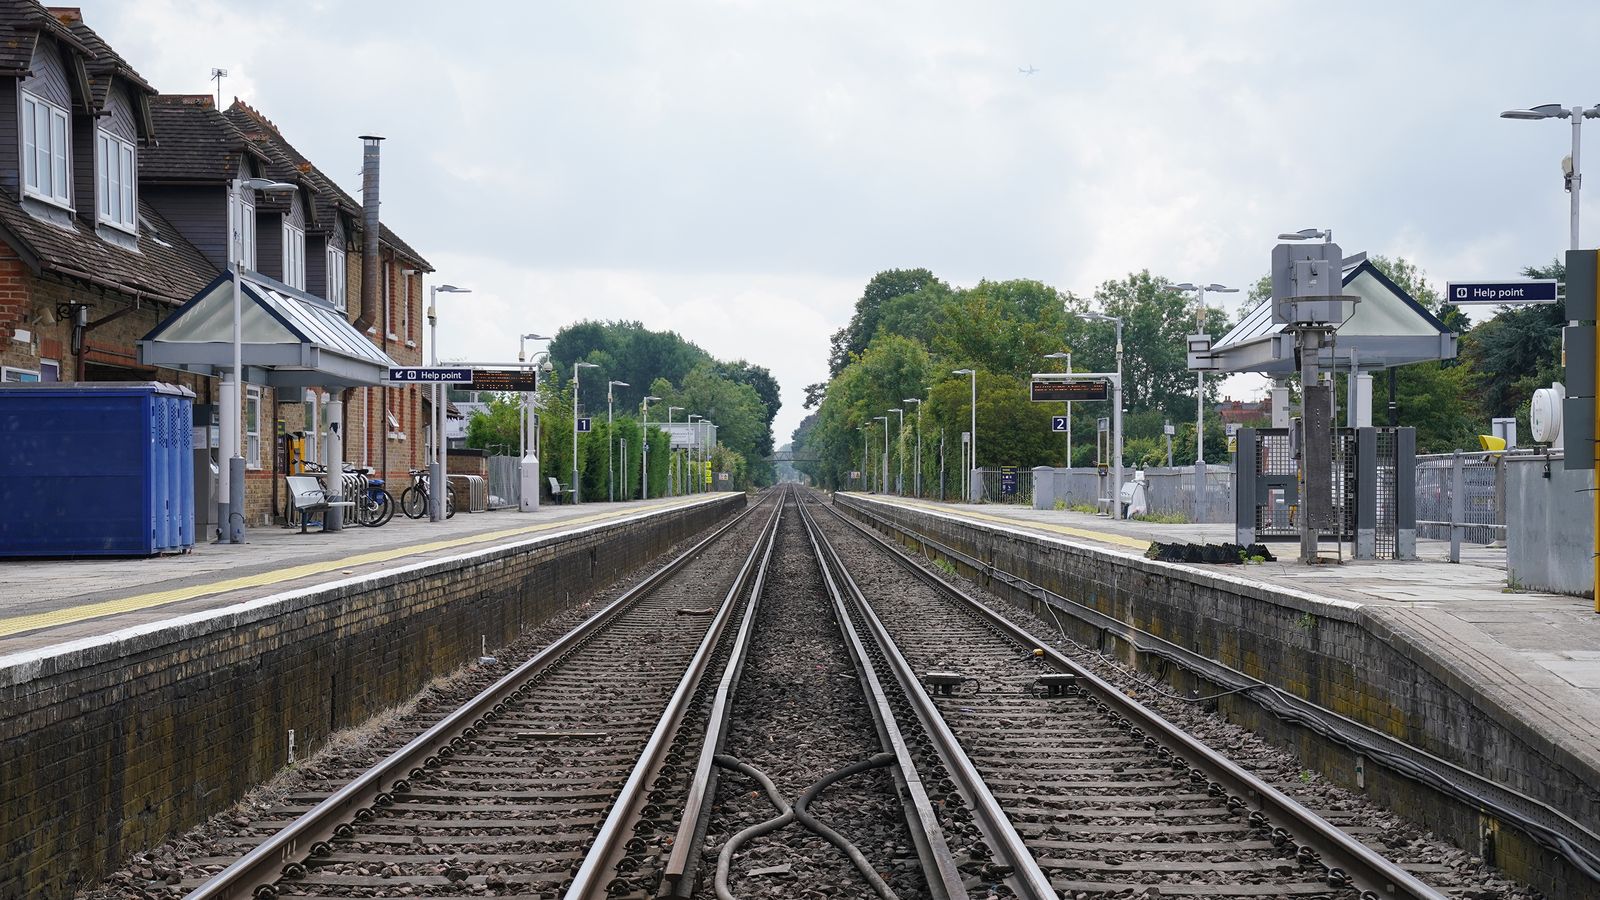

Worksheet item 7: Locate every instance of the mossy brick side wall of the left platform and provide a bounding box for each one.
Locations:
[0,495,746,897]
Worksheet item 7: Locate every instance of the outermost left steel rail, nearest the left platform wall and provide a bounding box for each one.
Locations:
[187,490,771,900]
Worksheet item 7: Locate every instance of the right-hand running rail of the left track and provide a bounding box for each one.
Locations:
[563,500,784,900]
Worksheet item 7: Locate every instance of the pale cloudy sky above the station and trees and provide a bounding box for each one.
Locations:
[82,0,1600,442]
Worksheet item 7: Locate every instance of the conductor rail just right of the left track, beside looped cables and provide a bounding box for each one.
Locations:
[662,490,789,897]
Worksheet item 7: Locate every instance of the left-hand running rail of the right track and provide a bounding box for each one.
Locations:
[818,490,1059,900]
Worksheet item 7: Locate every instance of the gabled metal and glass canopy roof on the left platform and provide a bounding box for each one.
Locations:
[139,271,397,388]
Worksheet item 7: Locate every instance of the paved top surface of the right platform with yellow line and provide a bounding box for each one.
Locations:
[850,493,1600,757]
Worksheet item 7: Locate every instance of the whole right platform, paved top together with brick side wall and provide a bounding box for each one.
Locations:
[835,493,1600,890]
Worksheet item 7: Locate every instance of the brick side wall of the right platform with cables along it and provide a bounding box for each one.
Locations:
[834,495,1600,897]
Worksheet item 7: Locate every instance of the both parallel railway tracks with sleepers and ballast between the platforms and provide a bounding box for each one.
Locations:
[175,490,1465,900]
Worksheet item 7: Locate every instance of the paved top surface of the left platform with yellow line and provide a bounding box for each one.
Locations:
[0,493,726,657]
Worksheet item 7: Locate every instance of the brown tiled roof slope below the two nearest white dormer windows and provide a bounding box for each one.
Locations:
[0,187,218,304]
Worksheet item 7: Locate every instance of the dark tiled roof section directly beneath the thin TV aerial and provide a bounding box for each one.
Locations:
[145,93,270,184]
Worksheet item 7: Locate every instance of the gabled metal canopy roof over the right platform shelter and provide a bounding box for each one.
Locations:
[1211,259,1456,375]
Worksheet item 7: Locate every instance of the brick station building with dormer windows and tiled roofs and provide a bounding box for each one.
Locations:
[0,0,432,535]
